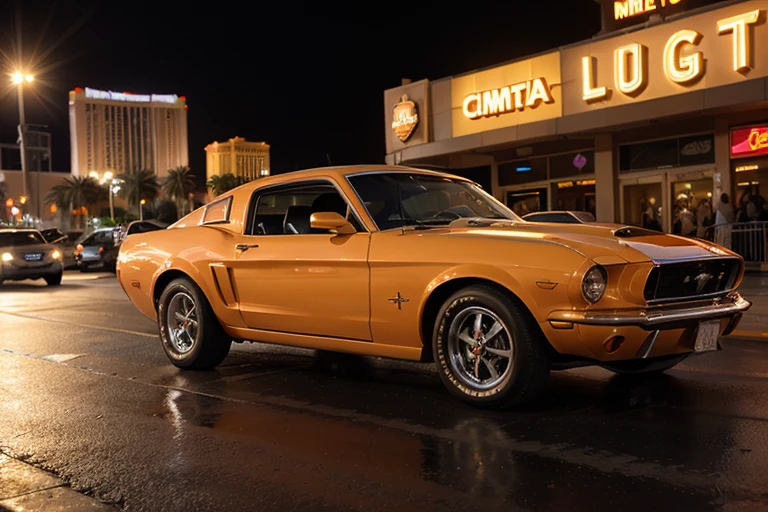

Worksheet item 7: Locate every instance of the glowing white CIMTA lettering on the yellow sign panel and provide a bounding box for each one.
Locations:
[463,78,555,119]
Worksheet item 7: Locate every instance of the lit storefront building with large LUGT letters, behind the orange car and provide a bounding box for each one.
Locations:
[384,0,768,268]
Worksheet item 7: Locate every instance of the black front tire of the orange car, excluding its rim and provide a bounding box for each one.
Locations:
[432,288,526,405]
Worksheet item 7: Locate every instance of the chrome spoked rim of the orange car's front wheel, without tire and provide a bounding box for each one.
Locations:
[447,306,515,391]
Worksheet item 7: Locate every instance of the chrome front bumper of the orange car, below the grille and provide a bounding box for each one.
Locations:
[547,293,752,331]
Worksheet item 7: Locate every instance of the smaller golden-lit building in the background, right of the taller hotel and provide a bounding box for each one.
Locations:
[205,137,270,180]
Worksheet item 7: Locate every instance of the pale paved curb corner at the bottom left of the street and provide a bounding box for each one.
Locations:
[0,453,118,512]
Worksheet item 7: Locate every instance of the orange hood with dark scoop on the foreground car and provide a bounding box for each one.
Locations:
[424,219,738,265]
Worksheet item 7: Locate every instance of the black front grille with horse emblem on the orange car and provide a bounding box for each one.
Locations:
[644,258,741,302]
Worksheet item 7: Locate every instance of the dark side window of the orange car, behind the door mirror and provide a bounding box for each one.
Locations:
[248,182,363,235]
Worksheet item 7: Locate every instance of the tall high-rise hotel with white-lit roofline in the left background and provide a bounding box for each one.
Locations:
[69,87,189,178]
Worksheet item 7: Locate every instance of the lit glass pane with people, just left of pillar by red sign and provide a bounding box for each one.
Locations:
[672,178,715,240]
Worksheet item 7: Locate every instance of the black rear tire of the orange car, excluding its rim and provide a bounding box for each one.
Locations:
[157,278,210,368]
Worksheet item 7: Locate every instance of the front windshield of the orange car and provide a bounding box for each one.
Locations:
[349,172,520,230]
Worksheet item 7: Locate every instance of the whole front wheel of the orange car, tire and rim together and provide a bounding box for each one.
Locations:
[433,286,550,407]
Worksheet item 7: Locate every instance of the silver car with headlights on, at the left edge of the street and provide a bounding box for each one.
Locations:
[0,229,64,286]
